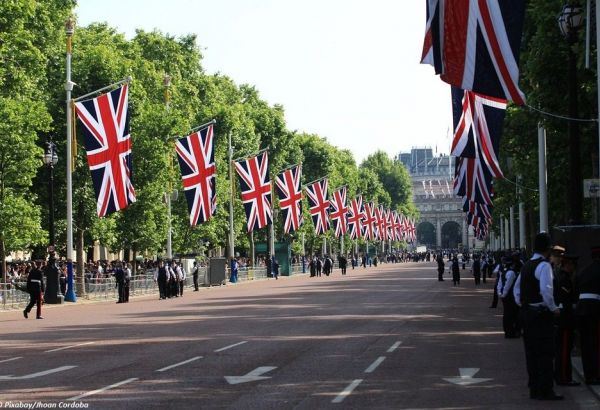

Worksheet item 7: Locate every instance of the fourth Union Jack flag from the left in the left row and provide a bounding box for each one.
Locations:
[275,165,303,233]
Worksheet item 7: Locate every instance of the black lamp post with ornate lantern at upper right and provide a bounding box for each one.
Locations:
[558,4,583,224]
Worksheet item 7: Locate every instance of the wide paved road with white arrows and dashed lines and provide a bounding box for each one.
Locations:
[0,263,600,409]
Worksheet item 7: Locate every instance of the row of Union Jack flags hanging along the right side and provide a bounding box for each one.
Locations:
[421,0,525,239]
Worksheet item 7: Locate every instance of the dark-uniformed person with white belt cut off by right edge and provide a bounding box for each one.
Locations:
[575,245,600,385]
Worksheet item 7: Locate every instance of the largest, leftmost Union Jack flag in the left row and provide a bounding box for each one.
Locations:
[75,84,135,217]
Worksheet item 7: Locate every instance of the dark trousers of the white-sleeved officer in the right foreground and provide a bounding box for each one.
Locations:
[521,307,554,396]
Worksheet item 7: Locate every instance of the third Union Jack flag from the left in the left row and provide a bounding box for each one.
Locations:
[235,151,273,232]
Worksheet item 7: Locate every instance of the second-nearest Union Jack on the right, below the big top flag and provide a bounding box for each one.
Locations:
[451,87,506,178]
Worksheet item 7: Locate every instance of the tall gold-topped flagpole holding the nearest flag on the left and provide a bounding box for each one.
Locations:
[65,17,77,302]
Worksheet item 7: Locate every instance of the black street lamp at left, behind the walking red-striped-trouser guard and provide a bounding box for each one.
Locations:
[43,138,64,304]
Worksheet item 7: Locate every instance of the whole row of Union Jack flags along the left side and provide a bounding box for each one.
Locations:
[75,84,416,241]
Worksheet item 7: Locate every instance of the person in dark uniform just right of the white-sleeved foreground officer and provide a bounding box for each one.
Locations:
[554,252,580,386]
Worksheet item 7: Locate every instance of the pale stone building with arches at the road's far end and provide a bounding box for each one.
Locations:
[396,148,480,250]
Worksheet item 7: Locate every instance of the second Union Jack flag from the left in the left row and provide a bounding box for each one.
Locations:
[175,124,217,226]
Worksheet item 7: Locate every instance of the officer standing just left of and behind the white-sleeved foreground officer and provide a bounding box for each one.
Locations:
[499,254,521,339]
